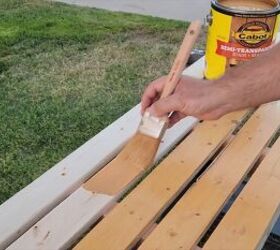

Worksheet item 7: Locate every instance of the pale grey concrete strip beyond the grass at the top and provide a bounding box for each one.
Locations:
[58,0,210,21]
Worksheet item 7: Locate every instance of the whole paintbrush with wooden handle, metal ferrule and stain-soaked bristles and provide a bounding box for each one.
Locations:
[119,21,201,168]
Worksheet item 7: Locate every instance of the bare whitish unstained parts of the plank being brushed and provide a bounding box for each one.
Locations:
[8,116,195,250]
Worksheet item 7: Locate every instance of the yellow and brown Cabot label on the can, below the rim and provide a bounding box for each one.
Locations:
[205,5,279,79]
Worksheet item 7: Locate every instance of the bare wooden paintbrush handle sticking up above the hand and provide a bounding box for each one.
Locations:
[160,21,201,98]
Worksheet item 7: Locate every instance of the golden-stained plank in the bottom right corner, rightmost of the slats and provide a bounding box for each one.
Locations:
[203,140,280,250]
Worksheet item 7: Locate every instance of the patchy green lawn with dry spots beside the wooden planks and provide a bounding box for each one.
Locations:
[0,0,192,204]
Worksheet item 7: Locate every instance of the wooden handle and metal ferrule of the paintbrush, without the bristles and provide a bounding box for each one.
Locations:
[138,21,201,139]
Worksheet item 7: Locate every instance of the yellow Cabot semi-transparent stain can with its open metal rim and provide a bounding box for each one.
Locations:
[204,0,280,79]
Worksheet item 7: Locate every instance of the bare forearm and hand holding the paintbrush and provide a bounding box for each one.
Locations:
[142,45,280,125]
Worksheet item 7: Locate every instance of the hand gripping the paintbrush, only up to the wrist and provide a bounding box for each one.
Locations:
[142,76,231,126]
